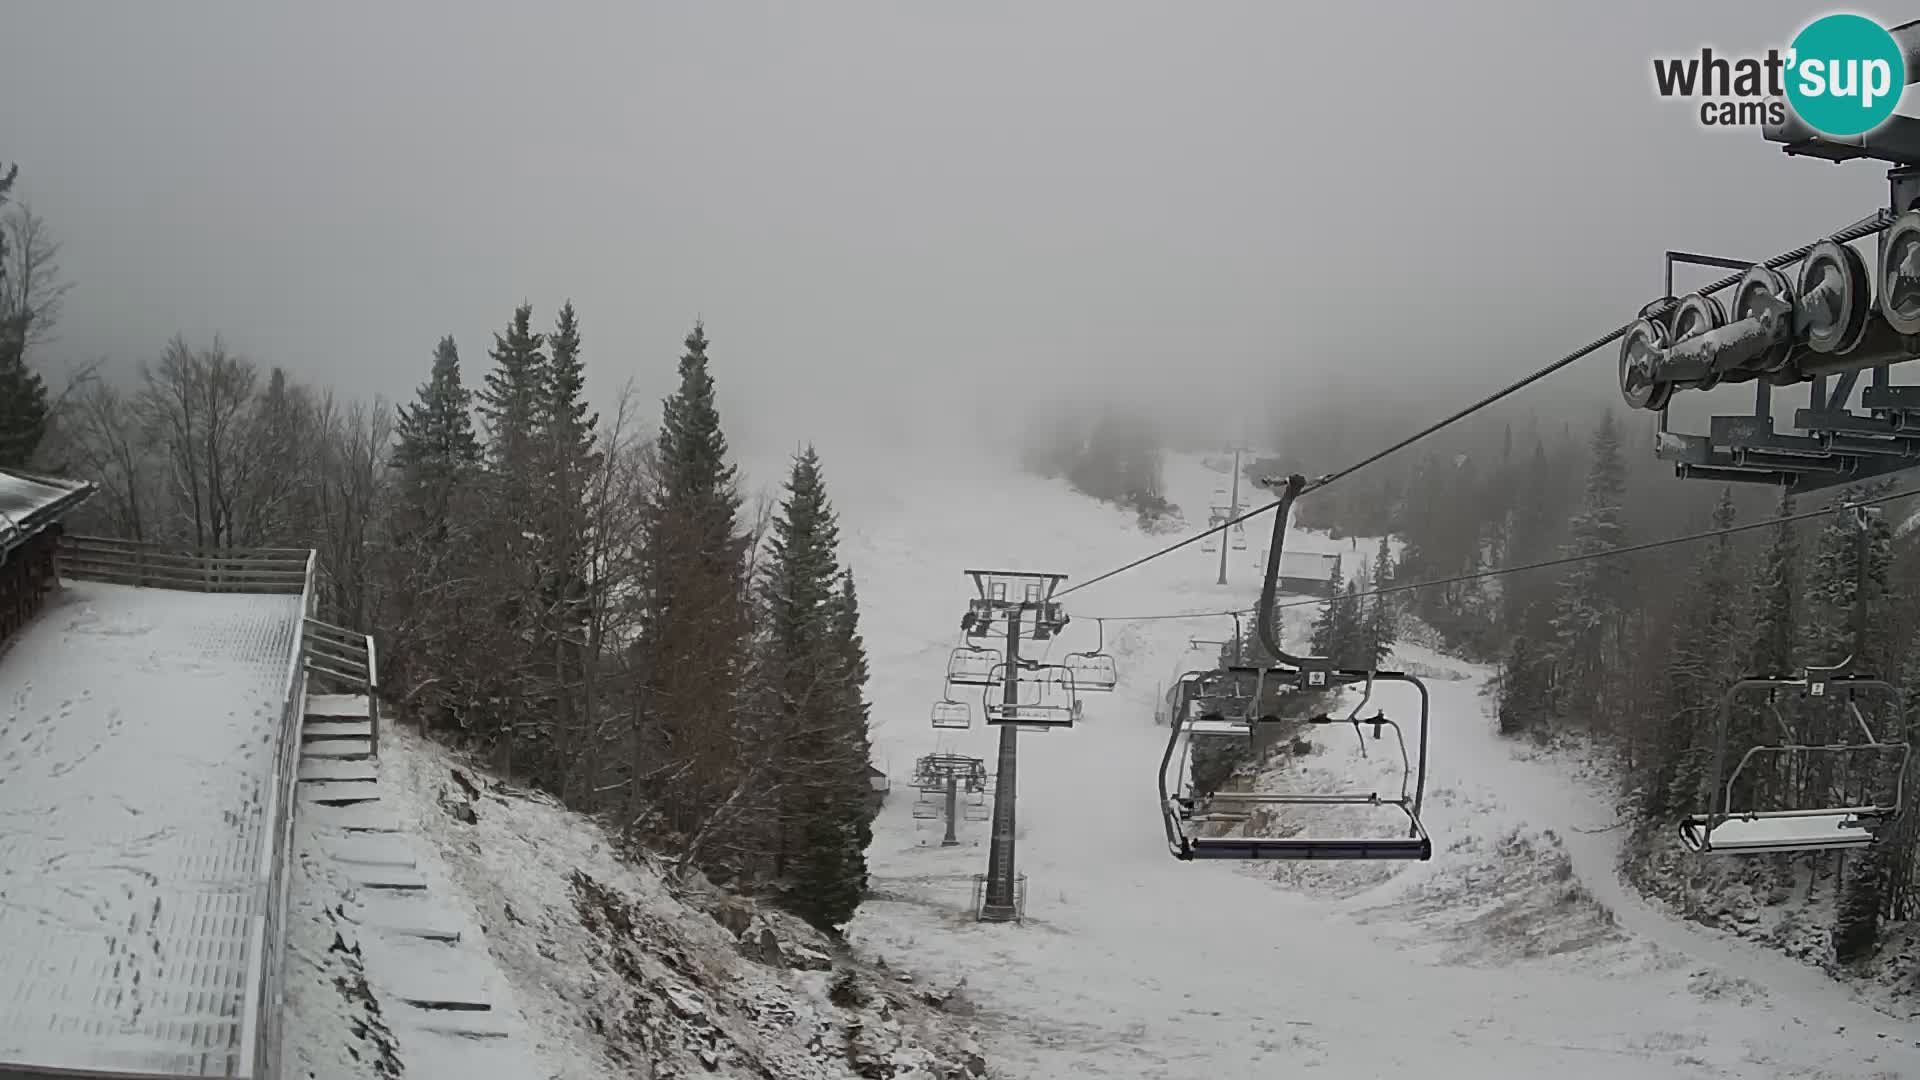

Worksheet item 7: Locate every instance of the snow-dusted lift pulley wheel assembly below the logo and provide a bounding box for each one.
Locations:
[1619,115,1920,492]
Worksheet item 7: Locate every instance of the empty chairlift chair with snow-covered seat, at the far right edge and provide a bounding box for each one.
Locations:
[1680,667,1912,855]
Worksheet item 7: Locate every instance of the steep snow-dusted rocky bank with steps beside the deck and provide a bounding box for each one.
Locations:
[286,703,981,1080]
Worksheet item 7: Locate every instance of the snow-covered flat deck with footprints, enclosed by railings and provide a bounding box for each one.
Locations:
[0,582,300,1076]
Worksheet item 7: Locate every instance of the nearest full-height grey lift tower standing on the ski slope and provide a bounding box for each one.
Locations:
[960,571,1068,922]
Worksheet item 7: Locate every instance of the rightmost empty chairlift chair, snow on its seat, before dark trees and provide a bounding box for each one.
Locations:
[1680,667,1910,855]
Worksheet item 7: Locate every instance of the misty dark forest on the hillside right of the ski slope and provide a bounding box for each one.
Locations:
[1283,390,1920,963]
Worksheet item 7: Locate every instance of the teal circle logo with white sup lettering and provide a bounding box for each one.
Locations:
[1788,15,1907,136]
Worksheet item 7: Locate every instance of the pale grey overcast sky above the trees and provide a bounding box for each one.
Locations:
[0,0,1916,461]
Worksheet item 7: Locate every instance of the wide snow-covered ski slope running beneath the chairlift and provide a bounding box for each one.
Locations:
[749,444,1920,1080]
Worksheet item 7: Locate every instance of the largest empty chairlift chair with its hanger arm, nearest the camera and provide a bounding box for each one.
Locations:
[1158,475,1432,861]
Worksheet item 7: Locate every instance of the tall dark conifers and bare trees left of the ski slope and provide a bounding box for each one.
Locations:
[0,165,876,930]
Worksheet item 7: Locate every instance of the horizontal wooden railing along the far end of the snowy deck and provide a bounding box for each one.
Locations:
[60,534,313,594]
